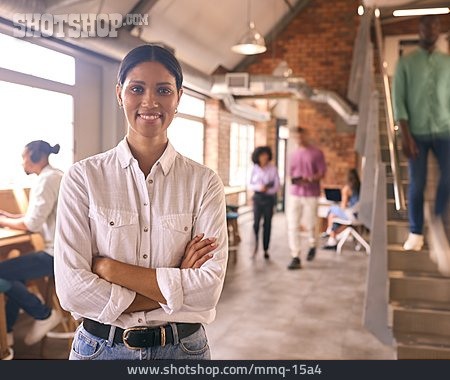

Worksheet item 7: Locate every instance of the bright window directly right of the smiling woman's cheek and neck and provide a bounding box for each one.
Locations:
[167,93,205,164]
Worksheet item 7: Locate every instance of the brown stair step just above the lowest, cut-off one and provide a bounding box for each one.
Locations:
[393,308,450,342]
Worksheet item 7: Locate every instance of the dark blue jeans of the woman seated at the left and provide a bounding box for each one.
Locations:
[0,251,53,332]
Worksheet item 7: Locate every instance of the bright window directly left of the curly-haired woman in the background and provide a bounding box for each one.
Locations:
[230,123,255,186]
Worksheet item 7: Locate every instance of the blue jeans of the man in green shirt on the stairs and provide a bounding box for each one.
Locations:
[408,137,450,235]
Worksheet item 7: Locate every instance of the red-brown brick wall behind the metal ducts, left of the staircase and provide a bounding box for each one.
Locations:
[247,0,360,186]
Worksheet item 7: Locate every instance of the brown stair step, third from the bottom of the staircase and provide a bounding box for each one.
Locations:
[389,272,450,310]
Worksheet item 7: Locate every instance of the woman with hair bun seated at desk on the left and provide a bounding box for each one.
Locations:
[0,140,63,345]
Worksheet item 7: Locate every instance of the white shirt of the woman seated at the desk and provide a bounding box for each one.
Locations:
[23,165,63,256]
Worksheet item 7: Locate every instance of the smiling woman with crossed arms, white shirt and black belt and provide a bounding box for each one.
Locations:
[55,44,228,360]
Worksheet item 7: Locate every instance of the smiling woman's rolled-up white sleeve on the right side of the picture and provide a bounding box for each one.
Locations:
[156,171,228,314]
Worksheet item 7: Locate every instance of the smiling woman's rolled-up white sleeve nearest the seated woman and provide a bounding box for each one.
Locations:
[55,163,136,324]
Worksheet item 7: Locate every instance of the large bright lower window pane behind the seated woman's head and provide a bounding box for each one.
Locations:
[0,81,73,187]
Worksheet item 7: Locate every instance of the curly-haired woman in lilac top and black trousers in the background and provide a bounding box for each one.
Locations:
[249,146,280,260]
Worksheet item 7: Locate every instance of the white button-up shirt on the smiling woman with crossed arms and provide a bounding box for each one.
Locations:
[55,139,228,328]
